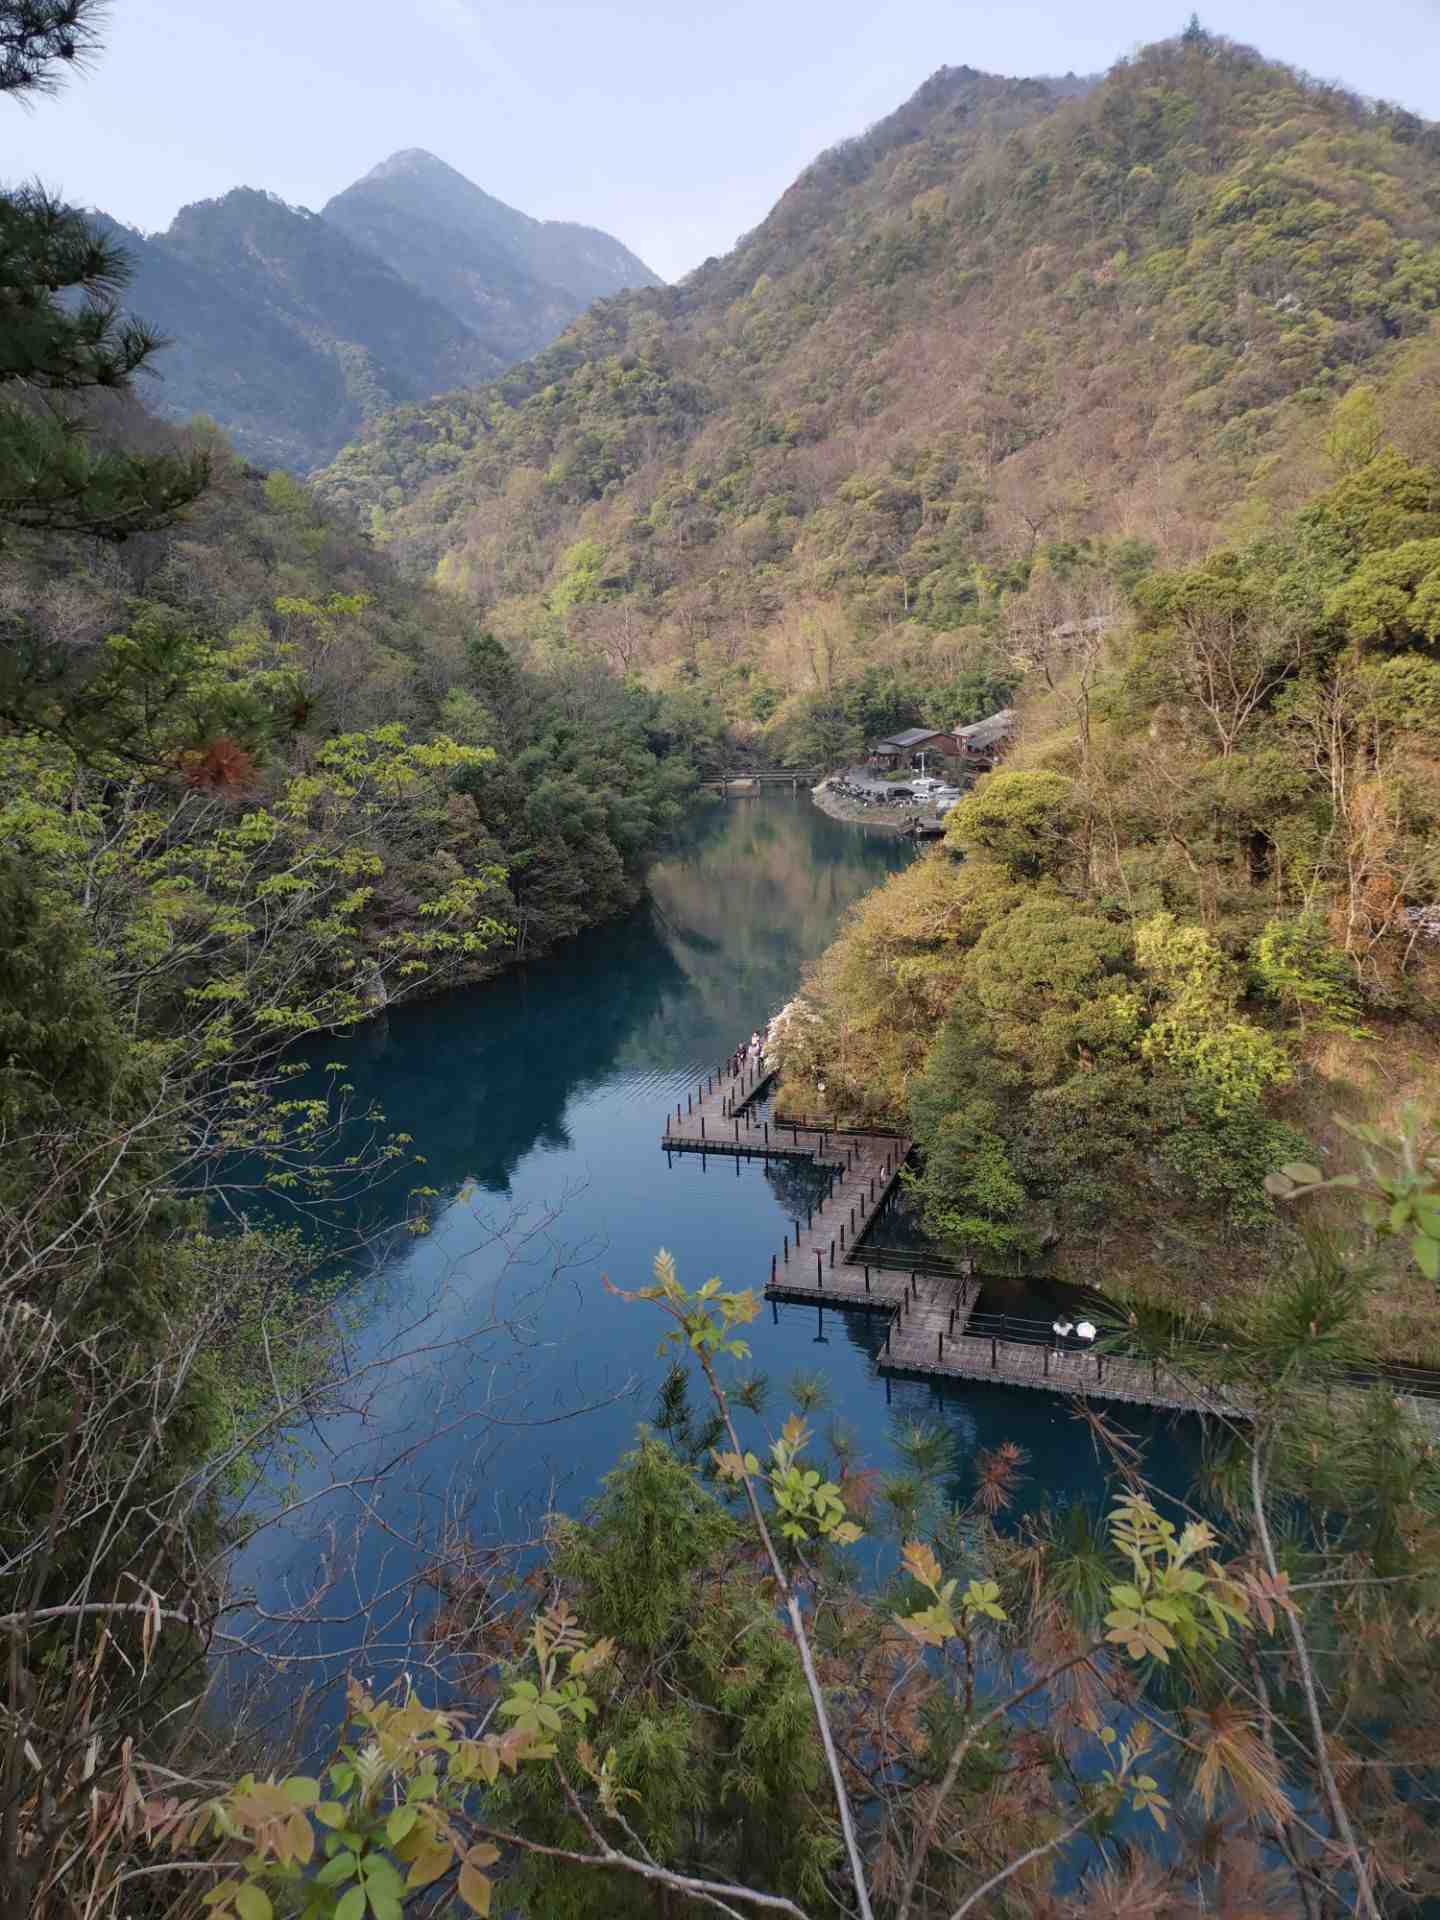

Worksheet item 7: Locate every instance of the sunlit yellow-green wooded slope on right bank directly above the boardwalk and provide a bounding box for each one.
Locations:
[785,441,1440,1363]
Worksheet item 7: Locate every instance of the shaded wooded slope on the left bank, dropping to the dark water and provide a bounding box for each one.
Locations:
[0,428,705,1000]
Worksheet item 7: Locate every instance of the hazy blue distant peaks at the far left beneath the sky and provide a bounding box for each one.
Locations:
[100,148,660,472]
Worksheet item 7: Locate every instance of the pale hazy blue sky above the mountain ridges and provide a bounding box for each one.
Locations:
[0,0,1440,278]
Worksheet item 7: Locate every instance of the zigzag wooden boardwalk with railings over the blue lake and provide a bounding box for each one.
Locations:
[660,1052,1244,1417]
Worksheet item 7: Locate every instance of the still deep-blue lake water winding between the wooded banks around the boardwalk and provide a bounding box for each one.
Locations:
[240,791,1188,1653]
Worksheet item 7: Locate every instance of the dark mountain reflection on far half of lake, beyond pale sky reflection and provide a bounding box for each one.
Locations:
[288,795,910,1233]
